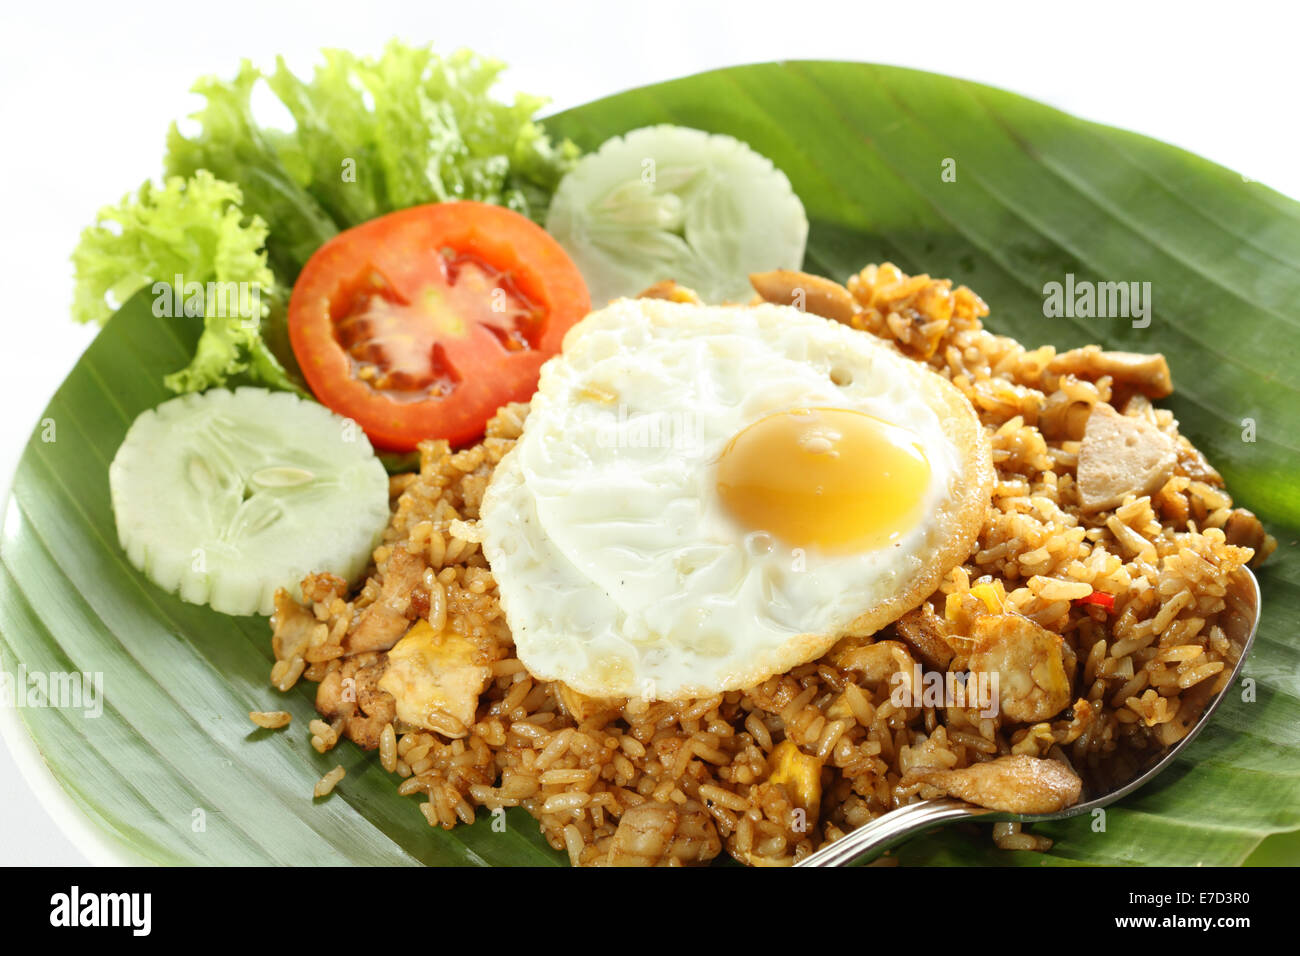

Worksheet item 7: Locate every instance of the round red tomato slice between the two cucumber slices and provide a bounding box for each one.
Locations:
[289,202,590,451]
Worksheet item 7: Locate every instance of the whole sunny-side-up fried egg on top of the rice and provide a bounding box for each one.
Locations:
[480,299,993,700]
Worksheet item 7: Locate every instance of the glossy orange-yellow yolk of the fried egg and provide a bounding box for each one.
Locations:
[718,408,930,551]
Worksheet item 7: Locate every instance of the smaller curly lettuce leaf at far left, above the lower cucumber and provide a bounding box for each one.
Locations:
[73,170,295,393]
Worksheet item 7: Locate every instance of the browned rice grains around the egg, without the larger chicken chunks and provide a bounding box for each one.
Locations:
[266,264,1268,865]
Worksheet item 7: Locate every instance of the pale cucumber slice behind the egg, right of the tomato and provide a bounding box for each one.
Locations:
[546,126,809,308]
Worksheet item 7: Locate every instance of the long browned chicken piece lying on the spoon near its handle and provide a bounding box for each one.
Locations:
[904,753,1083,813]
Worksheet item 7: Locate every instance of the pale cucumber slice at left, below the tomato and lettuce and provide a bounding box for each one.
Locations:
[108,388,389,614]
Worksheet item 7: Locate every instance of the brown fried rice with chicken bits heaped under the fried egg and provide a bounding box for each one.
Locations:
[263,264,1275,865]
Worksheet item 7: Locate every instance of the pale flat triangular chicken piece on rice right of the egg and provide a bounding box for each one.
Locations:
[1076,402,1178,511]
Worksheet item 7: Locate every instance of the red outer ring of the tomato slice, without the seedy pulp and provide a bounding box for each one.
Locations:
[289,200,590,451]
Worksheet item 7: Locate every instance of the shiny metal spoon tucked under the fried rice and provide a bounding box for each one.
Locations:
[796,568,1260,866]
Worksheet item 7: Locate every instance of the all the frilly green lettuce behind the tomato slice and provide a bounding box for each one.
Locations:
[73,42,579,392]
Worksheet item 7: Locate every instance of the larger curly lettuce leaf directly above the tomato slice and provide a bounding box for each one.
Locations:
[166,40,579,285]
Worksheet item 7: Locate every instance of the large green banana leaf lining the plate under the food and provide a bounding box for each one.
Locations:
[0,62,1300,866]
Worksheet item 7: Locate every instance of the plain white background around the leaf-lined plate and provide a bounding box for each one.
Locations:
[0,0,1300,864]
